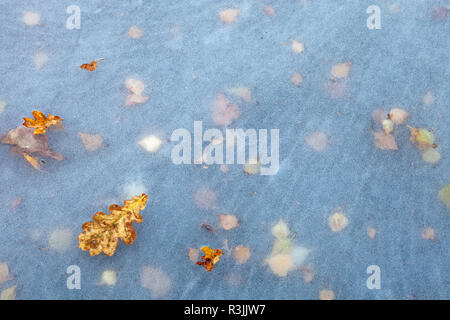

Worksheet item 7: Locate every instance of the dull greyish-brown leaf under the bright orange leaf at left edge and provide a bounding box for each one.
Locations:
[2,126,65,161]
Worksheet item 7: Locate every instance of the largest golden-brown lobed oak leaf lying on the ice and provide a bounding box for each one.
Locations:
[78,193,148,256]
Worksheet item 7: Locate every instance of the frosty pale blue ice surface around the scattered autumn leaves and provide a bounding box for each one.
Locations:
[0,0,450,299]
